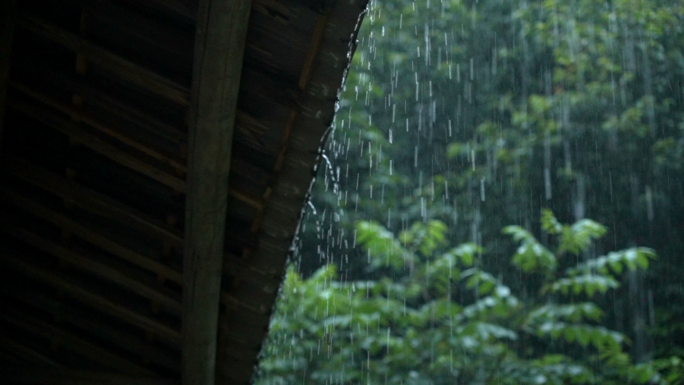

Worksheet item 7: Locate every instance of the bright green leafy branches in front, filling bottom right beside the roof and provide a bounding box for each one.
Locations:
[257,211,683,384]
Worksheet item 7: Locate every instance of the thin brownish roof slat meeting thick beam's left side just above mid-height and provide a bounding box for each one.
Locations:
[10,81,185,172]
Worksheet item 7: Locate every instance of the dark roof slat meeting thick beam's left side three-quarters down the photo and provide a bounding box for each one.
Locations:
[0,187,183,284]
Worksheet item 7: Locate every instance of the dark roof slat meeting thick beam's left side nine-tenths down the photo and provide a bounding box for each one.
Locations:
[0,251,180,344]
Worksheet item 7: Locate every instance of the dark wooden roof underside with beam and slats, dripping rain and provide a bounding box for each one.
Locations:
[0,0,366,385]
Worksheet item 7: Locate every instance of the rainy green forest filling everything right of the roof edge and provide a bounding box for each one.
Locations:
[257,0,684,384]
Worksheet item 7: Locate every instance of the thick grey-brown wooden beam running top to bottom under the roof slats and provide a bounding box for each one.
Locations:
[182,0,251,385]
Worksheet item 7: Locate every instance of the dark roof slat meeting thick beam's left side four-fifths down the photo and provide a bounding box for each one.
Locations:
[0,222,181,311]
